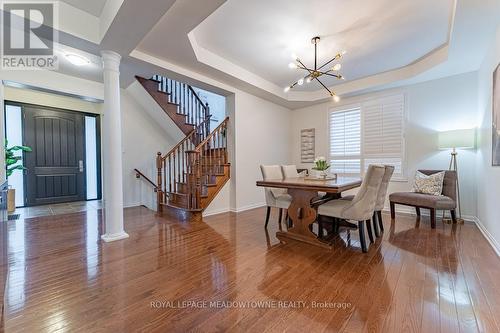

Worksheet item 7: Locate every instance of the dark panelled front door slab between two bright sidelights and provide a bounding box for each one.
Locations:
[23,105,86,206]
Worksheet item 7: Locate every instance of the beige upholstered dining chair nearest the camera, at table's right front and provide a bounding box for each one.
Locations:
[318,165,385,252]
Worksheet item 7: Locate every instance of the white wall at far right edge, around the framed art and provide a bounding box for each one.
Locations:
[476,28,500,255]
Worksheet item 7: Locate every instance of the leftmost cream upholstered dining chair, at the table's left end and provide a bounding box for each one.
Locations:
[260,165,292,228]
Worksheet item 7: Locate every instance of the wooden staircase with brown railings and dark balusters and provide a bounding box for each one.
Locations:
[136,75,230,220]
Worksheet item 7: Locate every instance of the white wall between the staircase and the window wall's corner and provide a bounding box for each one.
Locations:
[205,91,291,215]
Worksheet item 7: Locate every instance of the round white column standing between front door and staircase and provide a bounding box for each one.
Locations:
[101,51,128,242]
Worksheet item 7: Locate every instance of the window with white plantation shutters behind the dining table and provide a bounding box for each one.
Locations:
[329,95,405,178]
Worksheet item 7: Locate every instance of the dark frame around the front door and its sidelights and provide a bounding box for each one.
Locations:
[4,100,102,207]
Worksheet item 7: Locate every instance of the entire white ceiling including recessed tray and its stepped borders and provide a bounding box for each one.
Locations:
[12,0,500,109]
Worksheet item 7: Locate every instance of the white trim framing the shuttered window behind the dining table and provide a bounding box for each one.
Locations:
[326,92,409,182]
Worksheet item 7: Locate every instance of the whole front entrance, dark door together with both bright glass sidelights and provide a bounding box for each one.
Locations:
[5,101,102,207]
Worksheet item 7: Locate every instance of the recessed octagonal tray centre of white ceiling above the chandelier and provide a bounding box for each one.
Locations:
[194,0,453,90]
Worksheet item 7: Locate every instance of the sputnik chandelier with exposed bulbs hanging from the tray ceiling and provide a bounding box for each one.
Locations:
[285,37,345,102]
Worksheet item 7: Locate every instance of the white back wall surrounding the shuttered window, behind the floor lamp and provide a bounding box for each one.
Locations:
[292,72,477,217]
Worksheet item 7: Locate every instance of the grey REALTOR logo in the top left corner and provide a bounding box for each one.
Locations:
[1,1,58,70]
